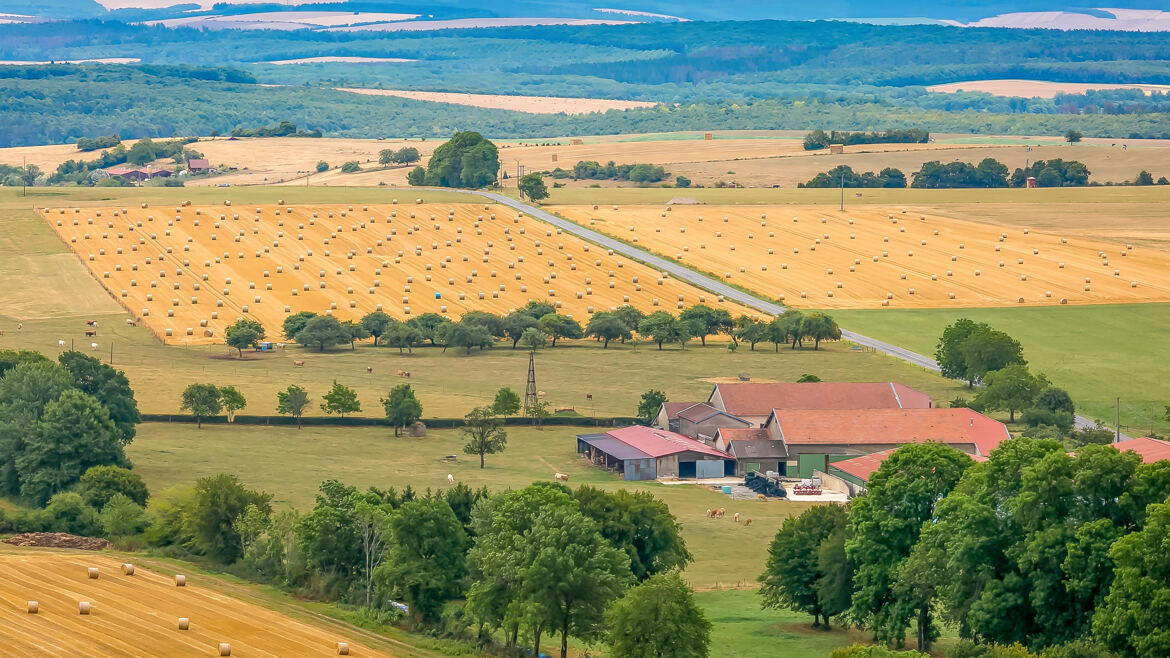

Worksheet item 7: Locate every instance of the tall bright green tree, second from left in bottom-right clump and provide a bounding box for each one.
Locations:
[845,443,971,651]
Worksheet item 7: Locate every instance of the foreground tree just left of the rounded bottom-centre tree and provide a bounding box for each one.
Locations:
[517,507,631,658]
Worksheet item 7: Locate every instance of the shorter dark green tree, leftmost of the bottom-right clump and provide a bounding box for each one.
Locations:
[759,505,849,629]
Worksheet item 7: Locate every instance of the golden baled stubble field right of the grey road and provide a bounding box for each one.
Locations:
[556,206,1170,308]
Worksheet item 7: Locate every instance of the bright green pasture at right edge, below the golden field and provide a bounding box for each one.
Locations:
[833,304,1170,436]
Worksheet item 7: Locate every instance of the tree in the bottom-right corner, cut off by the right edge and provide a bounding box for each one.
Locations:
[1093,502,1170,658]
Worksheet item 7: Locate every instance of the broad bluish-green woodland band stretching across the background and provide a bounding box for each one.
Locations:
[0,21,1170,145]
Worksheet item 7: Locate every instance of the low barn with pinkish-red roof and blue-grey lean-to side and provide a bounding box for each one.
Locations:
[577,425,736,480]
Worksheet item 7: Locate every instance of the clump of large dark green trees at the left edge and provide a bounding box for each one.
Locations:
[0,351,139,503]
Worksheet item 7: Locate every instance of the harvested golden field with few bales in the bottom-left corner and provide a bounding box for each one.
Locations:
[0,550,388,656]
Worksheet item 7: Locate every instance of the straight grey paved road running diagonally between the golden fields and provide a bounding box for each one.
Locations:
[436,189,1129,440]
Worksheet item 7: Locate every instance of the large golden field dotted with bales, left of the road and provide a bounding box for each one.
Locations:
[41,203,746,344]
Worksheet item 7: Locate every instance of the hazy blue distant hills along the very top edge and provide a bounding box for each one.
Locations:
[0,0,1157,29]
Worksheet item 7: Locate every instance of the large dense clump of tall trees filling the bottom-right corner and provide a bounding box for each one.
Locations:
[759,438,1170,658]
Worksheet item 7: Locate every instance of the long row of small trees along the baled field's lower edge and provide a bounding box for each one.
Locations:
[272,301,841,355]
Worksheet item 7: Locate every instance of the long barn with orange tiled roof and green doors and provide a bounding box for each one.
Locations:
[764,409,1011,478]
